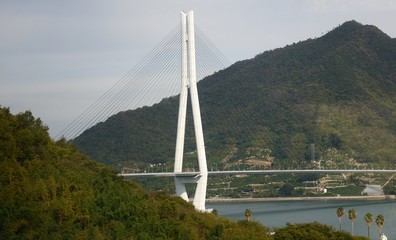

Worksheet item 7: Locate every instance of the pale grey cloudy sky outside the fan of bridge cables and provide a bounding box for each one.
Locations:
[0,0,396,136]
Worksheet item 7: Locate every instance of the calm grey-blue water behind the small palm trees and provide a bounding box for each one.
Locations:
[206,200,396,240]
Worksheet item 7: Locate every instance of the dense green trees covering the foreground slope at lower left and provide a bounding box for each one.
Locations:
[0,108,372,239]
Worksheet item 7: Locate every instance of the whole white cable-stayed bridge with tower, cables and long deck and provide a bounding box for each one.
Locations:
[59,11,396,211]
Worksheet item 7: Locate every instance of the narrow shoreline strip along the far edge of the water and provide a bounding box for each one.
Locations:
[206,195,396,203]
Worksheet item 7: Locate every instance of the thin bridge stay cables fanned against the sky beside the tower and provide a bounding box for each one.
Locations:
[55,13,231,139]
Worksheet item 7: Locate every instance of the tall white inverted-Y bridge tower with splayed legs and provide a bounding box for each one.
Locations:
[174,11,208,211]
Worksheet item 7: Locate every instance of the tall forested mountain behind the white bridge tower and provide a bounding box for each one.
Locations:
[74,21,396,169]
